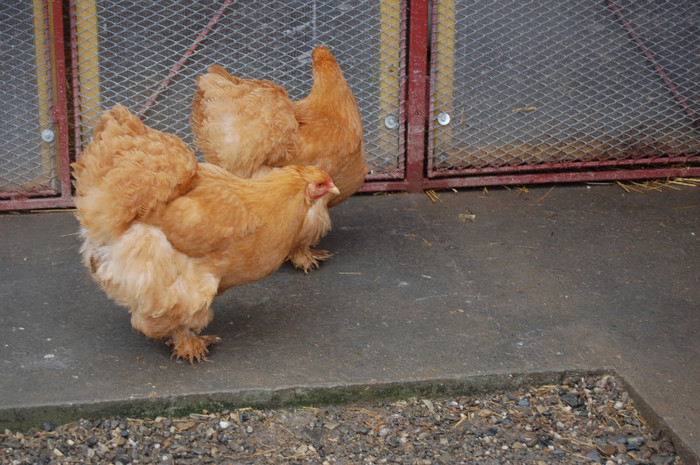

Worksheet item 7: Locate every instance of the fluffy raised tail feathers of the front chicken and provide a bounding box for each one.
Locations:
[72,105,197,243]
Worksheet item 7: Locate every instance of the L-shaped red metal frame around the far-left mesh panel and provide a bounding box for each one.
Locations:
[0,0,74,211]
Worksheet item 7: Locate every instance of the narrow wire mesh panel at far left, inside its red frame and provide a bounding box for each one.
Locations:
[0,0,57,192]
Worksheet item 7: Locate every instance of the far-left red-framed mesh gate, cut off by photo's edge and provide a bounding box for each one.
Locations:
[0,0,72,210]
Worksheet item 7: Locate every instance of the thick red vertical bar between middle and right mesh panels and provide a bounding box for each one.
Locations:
[406,0,429,192]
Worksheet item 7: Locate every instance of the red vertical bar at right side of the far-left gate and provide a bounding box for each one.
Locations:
[51,0,72,200]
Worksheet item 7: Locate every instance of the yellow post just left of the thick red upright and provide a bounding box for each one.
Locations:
[380,0,401,166]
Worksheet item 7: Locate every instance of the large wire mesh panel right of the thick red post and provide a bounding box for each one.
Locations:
[428,0,700,176]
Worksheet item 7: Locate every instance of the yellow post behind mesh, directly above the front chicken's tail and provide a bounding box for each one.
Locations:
[75,0,102,142]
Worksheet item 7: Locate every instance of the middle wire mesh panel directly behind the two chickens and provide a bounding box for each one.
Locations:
[72,0,404,178]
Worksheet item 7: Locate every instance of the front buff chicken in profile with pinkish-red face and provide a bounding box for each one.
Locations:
[72,105,339,362]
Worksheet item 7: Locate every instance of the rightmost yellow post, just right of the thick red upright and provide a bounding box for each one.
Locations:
[431,0,456,161]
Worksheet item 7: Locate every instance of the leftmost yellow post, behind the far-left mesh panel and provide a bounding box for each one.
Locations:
[33,0,55,185]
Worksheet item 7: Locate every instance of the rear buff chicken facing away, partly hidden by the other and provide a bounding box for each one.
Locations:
[191,46,367,272]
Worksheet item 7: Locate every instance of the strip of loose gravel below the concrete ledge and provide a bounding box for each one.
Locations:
[0,376,682,465]
